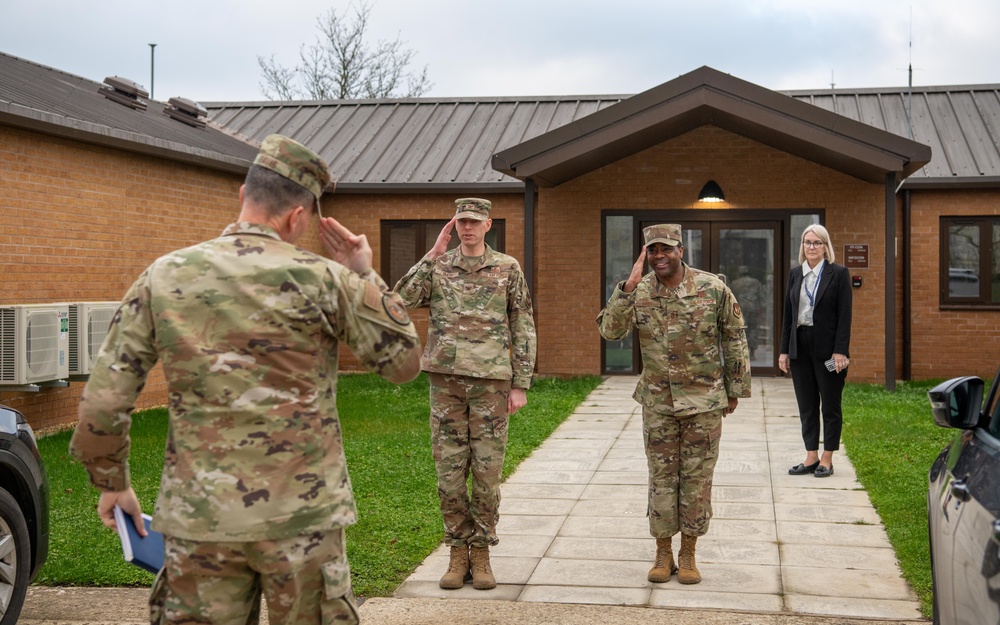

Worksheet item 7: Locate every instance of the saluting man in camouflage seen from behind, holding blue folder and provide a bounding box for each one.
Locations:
[70,135,420,625]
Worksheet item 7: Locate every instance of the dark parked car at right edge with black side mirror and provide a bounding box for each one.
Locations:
[927,371,1000,625]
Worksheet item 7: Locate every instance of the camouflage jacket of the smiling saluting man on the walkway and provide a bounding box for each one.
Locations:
[597,263,750,416]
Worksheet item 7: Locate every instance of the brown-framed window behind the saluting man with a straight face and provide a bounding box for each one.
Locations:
[381,219,505,288]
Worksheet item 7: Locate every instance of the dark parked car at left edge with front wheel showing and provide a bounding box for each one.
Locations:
[0,405,49,625]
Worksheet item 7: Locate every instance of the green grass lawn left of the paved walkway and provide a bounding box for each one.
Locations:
[35,375,601,596]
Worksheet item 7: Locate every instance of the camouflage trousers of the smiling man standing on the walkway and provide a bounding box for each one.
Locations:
[642,408,722,538]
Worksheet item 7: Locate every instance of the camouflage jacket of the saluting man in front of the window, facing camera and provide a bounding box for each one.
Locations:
[394,245,536,388]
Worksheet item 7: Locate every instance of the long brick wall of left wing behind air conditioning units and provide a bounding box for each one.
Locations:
[0,127,254,430]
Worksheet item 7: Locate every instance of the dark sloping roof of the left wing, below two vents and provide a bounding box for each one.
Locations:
[0,52,258,173]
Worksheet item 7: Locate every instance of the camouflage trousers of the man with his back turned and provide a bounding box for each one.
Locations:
[149,528,358,625]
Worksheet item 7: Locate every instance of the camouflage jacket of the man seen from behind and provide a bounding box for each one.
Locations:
[70,223,420,541]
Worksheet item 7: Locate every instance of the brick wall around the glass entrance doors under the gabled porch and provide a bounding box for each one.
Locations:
[535,126,885,382]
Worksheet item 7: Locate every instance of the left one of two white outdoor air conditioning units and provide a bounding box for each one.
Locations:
[0,304,69,385]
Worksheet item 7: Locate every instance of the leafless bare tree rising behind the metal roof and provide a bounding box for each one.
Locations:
[257,0,433,100]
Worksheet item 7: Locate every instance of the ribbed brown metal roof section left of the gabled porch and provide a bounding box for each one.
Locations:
[203,96,626,192]
